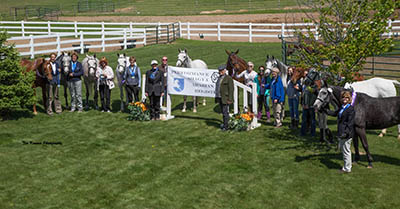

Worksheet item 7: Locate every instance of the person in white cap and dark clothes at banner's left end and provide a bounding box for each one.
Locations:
[145,60,164,120]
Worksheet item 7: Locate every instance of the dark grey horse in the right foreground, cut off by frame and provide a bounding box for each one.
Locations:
[314,84,400,168]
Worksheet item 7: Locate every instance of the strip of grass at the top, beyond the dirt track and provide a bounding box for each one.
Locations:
[0,0,298,19]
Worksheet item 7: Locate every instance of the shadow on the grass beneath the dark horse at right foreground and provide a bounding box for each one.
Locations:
[295,153,400,169]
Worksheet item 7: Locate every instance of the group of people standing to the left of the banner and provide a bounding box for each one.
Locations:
[46,53,168,120]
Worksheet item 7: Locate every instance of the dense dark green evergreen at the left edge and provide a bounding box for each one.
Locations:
[0,32,36,117]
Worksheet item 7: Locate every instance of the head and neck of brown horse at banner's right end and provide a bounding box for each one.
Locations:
[225,49,249,83]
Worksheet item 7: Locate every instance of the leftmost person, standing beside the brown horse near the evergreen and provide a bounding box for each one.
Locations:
[46,53,62,115]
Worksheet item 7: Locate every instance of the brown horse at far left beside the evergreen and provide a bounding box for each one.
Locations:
[20,58,53,115]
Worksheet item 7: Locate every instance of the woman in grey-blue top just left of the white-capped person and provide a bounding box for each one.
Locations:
[123,57,141,103]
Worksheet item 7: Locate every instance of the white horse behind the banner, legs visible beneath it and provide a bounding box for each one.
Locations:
[176,49,208,112]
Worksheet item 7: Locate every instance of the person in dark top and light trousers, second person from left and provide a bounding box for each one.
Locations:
[67,53,83,112]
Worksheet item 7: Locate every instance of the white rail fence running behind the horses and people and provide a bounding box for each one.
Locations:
[0,20,400,57]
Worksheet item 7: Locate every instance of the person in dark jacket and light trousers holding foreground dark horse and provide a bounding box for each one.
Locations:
[326,91,355,173]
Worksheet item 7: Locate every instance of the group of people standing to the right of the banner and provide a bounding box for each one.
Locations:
[215,62,355,173]
